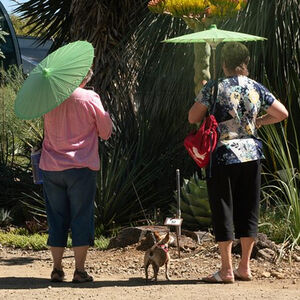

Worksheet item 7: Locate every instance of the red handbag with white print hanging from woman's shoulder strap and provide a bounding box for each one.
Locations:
[184,80,219,168]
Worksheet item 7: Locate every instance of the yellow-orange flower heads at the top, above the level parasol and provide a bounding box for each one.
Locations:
[148,0,247,19]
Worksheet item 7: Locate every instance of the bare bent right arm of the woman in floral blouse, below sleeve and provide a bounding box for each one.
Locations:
[256,100,289,128]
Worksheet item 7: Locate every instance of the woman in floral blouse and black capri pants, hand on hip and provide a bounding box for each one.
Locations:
[189,42,288,283]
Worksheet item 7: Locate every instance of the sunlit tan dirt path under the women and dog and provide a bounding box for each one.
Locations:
[0,248,300,300]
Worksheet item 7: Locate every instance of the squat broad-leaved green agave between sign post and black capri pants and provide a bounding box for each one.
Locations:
[171,173,211,230]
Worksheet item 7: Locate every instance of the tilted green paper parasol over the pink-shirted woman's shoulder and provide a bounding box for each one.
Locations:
[15,41,94,120]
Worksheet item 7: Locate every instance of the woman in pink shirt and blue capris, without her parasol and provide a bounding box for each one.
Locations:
[40,70,112,283]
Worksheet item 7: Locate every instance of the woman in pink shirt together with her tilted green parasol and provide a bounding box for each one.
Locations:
[15,41,112,283]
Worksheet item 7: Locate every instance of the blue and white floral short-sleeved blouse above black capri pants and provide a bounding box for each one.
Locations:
[196,76,275,165]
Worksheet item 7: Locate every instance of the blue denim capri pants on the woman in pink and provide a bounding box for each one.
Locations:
[42,168,97,247]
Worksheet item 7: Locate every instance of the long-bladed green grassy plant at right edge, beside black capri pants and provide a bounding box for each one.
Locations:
[262,119,300,248]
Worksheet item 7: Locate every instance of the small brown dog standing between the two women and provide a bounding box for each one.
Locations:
[144,232,170,281]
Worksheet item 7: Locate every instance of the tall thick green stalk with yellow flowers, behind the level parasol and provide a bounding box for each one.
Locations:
[148,0,247,95]
